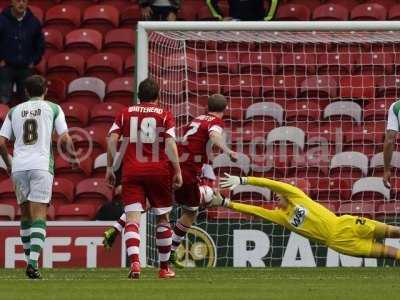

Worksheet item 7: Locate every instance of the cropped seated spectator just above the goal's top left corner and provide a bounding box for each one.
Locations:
[139,0,181,21]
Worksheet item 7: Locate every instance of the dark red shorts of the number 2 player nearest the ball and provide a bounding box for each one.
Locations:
[175,166,200,210]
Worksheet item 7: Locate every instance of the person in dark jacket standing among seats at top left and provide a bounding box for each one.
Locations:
[0,0,45,103]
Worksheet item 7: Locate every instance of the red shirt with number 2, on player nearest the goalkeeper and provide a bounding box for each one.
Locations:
[179,114,224,173]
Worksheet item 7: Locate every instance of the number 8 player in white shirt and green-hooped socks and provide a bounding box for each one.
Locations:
[0,75,77,279]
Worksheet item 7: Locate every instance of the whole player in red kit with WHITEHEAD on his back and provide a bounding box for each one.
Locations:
[106,79,182,279]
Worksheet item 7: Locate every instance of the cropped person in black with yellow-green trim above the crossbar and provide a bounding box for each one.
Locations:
[206,0,278,21]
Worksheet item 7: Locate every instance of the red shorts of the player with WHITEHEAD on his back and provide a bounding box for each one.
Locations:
[122,174,173,215]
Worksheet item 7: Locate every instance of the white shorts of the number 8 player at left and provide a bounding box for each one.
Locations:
[12,170,54,205]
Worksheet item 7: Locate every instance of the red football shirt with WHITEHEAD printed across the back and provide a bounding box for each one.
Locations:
[109,103,175,176]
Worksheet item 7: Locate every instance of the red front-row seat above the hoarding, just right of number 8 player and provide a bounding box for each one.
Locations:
[55,203,99,221]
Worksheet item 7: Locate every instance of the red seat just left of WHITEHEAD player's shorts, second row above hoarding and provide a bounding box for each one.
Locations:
[75,178,113,206]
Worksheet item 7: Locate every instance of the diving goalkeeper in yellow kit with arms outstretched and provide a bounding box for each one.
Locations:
[211,173,400,260]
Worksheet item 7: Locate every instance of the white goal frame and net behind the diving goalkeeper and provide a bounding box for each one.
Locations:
[137,22,400,267]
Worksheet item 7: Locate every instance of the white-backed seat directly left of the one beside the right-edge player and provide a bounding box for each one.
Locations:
[329,151,368,180]
